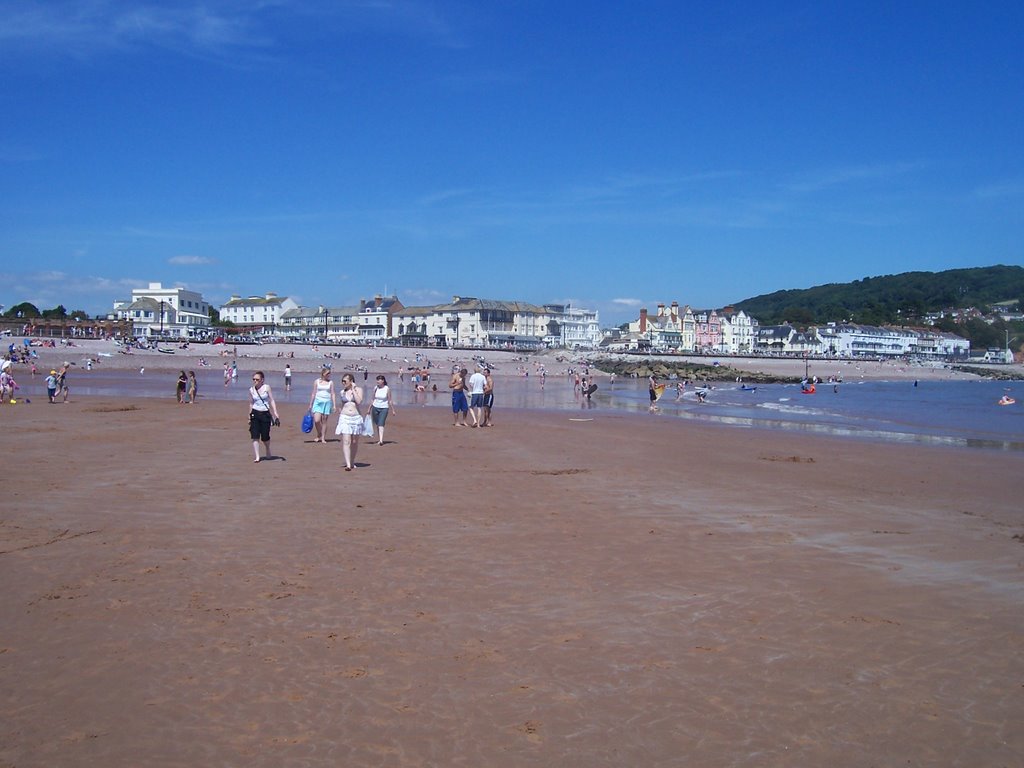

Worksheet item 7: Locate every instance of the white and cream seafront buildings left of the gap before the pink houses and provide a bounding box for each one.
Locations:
[114,283,603,349]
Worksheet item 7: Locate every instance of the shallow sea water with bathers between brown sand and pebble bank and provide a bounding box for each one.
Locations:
[20,369,1024,451]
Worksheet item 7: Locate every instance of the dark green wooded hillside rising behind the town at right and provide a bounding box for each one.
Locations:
[735,265,1024,326]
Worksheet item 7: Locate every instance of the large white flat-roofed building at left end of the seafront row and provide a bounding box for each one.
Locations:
[114,283,210,339]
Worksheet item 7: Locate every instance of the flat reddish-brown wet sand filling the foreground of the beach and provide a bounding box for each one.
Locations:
[0,397,1024,768]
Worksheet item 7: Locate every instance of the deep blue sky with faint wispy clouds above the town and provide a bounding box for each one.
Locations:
[0,0,1024,325]
